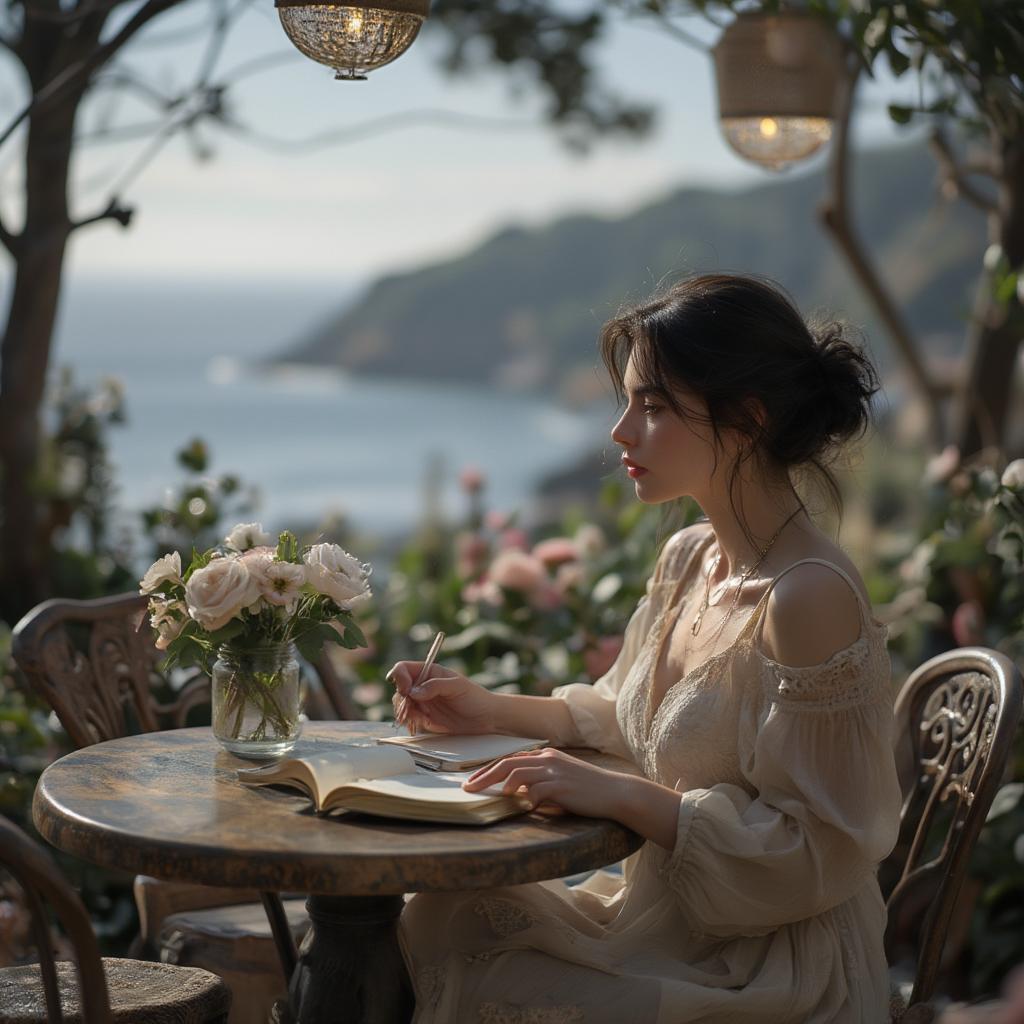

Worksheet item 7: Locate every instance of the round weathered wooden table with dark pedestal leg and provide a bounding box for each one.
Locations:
[33,722,641,1024]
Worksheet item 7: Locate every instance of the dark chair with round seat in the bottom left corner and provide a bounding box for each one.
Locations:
[0,817,231,1024]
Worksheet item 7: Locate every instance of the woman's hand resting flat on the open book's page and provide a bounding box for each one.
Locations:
[462,746,629,818]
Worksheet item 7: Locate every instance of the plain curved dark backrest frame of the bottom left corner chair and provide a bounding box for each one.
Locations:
[0,817,112,1024]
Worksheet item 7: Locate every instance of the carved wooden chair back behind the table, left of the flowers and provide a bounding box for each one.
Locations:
[11,594,209,746]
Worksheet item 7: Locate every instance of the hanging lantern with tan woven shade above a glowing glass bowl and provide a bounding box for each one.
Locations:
[714,10,844,170]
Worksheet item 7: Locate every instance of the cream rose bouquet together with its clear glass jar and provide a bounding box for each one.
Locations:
[139,523,371,758]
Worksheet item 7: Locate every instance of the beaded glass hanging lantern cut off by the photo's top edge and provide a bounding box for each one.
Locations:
[274,0,430,82]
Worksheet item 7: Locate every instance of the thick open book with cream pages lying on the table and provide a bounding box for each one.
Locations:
[238,744,529,825]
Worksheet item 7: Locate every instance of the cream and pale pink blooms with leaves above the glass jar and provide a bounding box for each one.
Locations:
[139,523,371,670]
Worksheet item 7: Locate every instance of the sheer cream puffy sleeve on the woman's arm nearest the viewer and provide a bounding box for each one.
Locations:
[663,635,901,936]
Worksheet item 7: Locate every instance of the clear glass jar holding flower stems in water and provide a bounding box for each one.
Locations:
[212,643,302,759]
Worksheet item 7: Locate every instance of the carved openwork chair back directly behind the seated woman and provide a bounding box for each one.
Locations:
[881,647,1021,1006]
